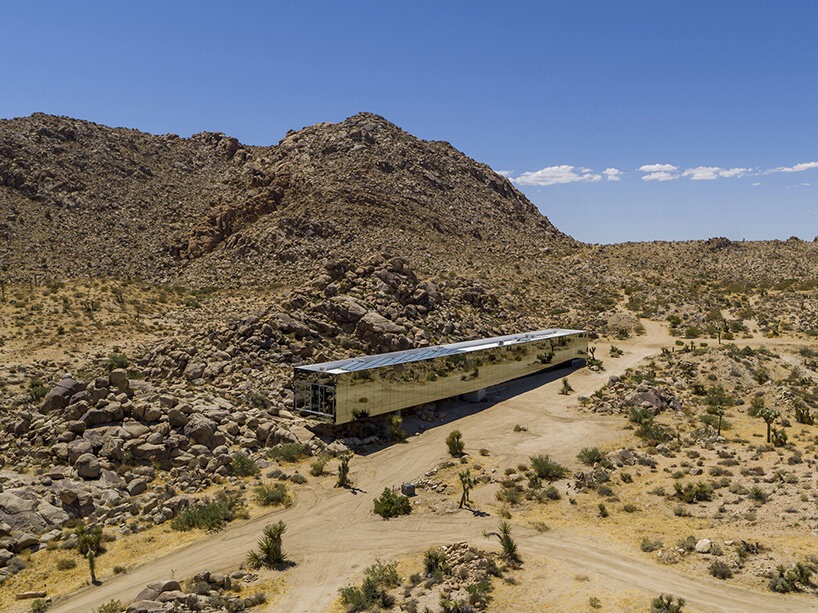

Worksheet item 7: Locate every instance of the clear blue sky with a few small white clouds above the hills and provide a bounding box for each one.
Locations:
[0,0,818,242]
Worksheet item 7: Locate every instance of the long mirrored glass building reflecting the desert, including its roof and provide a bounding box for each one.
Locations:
[294,330,588,423]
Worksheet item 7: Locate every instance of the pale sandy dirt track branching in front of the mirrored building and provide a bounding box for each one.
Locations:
[50,322,818,613]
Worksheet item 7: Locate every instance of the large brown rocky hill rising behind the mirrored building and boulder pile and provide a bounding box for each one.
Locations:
[0,113,575,286]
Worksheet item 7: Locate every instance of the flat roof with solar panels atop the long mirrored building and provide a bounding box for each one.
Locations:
[296,328,582,374]
